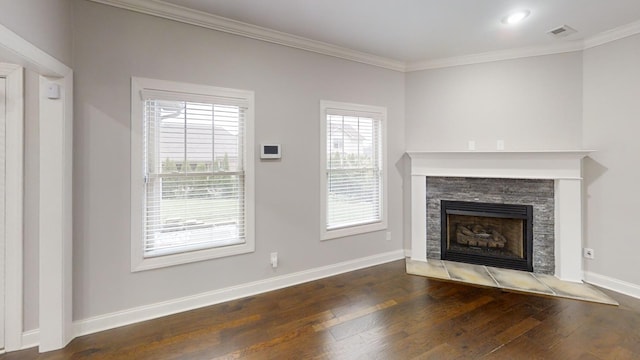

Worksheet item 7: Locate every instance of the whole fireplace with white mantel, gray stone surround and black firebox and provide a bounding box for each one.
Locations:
[408,150,589,282]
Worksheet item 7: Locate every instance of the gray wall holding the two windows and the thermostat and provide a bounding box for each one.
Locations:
[73,0,405,319]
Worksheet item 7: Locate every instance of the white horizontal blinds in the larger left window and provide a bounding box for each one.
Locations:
[142,91,247,258]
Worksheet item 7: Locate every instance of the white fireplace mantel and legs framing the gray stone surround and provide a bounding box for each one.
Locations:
[407,150,593,282]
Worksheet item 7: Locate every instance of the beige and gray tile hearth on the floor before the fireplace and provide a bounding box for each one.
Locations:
[407,259,618,305]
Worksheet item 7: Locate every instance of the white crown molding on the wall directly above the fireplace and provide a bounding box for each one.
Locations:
[405,41,583,72]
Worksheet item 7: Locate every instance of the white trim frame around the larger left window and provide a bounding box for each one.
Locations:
[131,77,255,272]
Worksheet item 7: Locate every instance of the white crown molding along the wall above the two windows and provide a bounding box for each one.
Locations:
[91,0,405,71]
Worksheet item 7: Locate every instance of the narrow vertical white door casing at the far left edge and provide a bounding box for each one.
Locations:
[0,63,24,350]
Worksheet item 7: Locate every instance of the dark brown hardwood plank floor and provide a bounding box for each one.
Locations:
[5,261,640,360]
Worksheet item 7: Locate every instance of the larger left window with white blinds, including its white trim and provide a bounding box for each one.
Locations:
[131,78,255,271]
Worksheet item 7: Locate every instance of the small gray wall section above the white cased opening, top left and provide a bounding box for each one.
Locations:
[0,0,73,65]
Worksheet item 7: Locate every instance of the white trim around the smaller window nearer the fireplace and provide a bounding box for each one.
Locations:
[320,100,388,241]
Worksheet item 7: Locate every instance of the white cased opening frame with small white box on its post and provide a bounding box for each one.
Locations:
[0,24,74,352]
